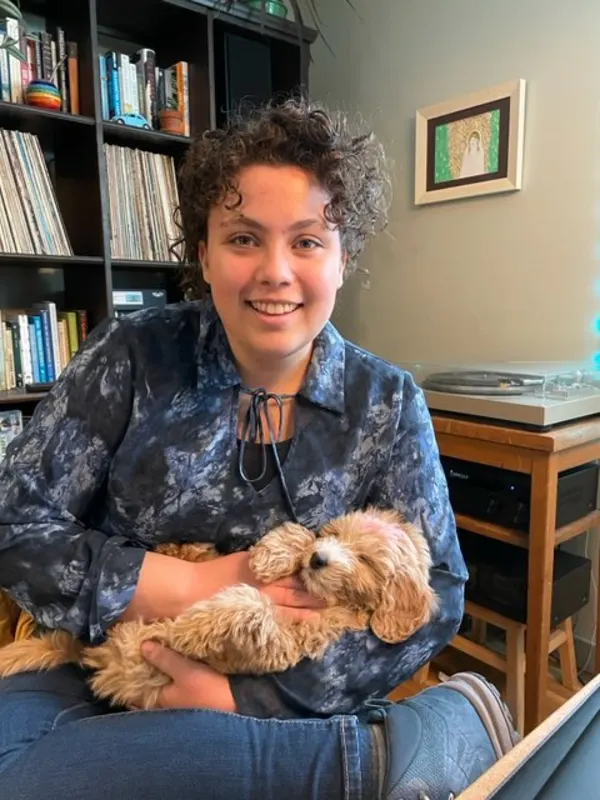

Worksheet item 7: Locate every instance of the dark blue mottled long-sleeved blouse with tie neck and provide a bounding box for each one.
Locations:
[0,300,466,717]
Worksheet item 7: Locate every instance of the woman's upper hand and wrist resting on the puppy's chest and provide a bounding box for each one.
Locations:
[190,551,325,621]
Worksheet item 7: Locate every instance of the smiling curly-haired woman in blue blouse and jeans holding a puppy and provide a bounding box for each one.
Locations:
[0,101,508,800]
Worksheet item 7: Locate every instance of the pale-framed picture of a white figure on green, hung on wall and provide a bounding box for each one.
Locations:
[415,79,525,205]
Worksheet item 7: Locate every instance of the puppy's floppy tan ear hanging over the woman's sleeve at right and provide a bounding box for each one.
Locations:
[371,568,438,644]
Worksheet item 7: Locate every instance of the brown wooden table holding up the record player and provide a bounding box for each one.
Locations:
[432,412,600,732]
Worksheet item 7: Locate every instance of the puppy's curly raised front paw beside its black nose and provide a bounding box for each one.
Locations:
[250,522,315,583]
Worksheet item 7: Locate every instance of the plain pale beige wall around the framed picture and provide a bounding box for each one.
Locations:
[311,0,600,668]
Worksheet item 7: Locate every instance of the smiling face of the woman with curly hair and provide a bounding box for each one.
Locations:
[199,165,345,380]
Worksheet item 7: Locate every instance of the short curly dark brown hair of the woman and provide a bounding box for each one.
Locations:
[173,98,390,299]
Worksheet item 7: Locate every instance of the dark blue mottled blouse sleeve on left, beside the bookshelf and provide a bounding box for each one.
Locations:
[0,319,144,643]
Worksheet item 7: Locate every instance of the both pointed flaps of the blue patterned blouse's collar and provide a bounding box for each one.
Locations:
[198,297,346,414]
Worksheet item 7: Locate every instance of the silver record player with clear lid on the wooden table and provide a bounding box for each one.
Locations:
[401,361,600,428]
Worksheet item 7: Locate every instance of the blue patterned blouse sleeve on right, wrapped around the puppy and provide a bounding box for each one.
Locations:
[231,375,467,718]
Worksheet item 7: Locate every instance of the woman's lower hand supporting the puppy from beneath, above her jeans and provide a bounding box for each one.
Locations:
[142,642,236,712]
